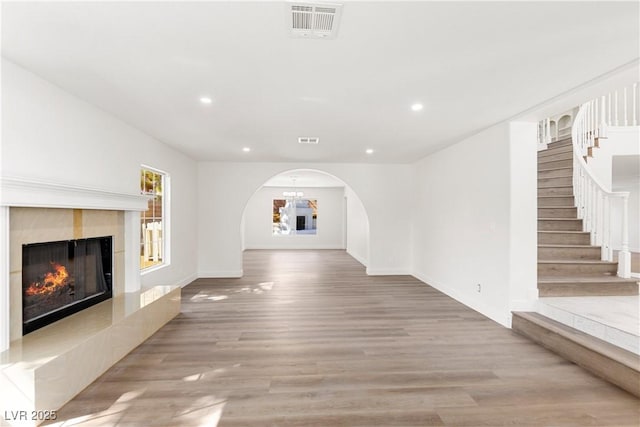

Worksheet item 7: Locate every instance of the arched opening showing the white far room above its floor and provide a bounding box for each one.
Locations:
[241,169,369,266]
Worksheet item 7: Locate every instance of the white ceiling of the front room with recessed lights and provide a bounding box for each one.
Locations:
[2,1,640,163]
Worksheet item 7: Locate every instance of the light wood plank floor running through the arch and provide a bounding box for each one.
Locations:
[47,251,640,427]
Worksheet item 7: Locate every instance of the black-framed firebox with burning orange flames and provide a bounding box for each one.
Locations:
[22,236,113,335]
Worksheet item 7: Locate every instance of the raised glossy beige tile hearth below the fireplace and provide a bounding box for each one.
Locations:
[0,286,181,426]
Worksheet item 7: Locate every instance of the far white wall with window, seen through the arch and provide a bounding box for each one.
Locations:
[243,187,345,249]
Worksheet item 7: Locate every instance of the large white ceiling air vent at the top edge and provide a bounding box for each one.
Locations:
[288,3,342,39]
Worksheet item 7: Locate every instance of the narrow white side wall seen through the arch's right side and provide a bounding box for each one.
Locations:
[345,187,369,267]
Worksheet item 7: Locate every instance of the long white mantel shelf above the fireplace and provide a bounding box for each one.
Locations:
[0,177,149,212]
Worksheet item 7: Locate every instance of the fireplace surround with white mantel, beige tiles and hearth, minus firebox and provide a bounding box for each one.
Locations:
[0,178,180,425]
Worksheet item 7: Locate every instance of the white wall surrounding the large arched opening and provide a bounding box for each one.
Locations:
[198,162,411,277]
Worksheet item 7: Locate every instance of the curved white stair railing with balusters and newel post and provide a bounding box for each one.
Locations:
[571,98,640,278]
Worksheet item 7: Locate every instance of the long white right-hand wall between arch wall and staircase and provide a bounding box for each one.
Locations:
[412,123,537,325]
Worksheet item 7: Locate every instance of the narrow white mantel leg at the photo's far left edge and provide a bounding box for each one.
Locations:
[0,206,11,352]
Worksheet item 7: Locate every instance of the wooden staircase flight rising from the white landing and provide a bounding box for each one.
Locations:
[538,138,638,297]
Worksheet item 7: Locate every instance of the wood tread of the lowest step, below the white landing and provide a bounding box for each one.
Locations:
[513,311,640,371]
